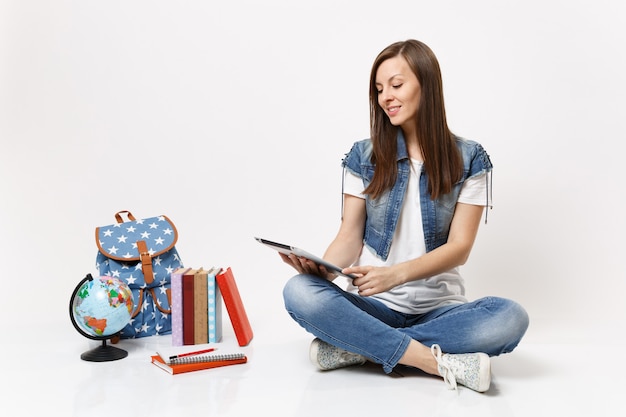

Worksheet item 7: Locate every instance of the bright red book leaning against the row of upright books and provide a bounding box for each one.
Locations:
[215,267,253,346]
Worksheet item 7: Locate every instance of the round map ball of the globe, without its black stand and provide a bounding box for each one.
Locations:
[72,276,133,337]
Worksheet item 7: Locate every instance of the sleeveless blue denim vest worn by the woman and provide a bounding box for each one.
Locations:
[342,130,493,260]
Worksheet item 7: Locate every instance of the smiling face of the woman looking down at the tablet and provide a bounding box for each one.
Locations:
[376,55,421,134]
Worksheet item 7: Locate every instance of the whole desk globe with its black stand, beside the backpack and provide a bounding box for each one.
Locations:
[70,274,133,362]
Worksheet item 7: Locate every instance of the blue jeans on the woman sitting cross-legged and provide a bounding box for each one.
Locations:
[283,274,529,373]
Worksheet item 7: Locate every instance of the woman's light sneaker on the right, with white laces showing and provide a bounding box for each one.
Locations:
[430,345,491,392]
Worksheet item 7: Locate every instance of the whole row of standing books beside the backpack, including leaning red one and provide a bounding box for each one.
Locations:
[171,267,253,346]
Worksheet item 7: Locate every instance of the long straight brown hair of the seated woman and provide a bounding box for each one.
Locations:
[365,39,463,200]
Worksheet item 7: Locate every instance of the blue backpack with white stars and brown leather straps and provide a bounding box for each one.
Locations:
[96,210,183,339]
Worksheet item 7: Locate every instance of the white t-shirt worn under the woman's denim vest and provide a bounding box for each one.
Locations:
[343,159,491,314]
